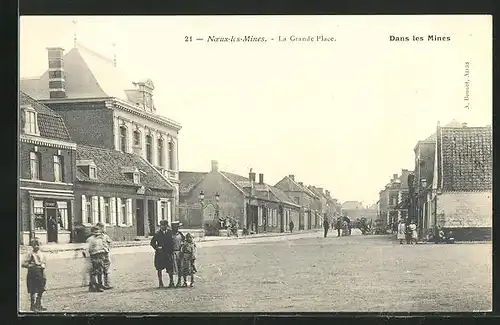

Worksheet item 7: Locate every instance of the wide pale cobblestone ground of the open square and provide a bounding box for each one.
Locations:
[20,233,492,313]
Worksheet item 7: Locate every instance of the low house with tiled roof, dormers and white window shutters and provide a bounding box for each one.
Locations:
[74,145,174,241]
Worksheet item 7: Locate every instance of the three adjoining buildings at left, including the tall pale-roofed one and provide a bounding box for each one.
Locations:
[18,44,181,244]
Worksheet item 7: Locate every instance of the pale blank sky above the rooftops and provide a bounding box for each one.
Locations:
[19,15,492,205]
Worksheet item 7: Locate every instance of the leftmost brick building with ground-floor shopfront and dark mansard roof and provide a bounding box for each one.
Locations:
[18,92,76,245]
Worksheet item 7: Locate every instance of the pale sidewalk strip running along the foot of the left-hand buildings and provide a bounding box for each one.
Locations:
[19,229,322,254]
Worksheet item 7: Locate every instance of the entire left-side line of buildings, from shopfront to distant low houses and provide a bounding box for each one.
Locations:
[18,44,339,244]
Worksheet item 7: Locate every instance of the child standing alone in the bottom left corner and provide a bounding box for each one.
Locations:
[21,238,47,311]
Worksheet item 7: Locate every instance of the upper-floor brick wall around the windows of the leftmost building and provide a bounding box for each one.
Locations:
[19,142,76,183]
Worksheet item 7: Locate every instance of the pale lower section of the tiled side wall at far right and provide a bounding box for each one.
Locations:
[437,191,493,228]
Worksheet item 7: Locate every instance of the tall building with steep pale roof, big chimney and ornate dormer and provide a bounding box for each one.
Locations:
[20,44,181,216]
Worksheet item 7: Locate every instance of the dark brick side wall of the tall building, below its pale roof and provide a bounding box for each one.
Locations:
[45,102,114,149]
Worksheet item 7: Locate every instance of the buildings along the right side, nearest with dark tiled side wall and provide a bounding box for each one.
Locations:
[379,120,493,240]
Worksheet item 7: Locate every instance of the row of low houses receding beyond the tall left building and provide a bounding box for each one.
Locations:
[179,160,339,233]
